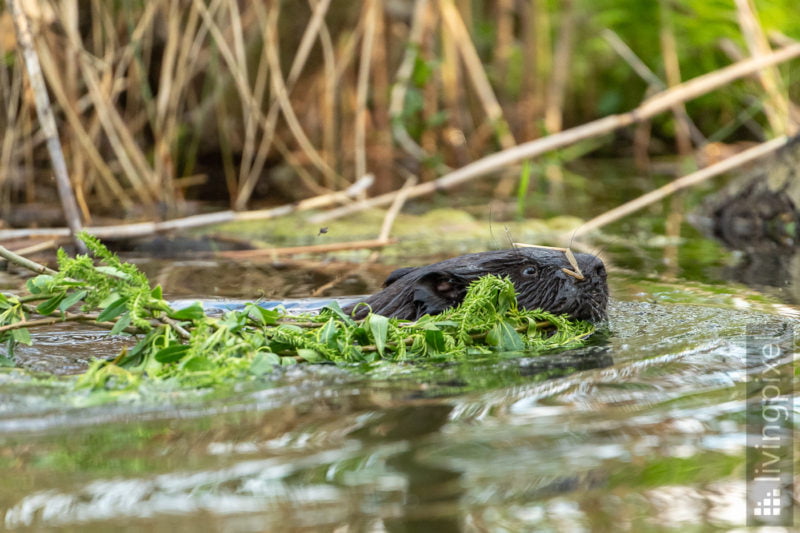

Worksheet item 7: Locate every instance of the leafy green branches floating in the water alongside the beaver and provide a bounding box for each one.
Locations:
[0,234,595,390]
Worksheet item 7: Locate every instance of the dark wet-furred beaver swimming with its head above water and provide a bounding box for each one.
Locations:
[345,248,608,322]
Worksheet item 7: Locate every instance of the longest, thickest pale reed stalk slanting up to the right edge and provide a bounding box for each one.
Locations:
[310,43,800,223]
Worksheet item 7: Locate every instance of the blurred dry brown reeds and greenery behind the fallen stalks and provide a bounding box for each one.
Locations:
[0,0,800,225]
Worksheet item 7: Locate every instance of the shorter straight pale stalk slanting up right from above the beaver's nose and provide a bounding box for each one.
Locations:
[564,136,789,238]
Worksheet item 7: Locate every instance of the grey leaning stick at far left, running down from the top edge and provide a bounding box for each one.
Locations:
[6,0,86,251]
